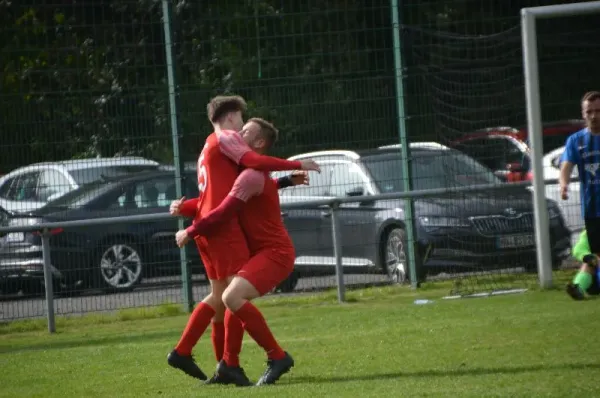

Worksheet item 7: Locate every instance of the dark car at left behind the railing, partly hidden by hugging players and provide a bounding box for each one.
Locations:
[0,171,203,291]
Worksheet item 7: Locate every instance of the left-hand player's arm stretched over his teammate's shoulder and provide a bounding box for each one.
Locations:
[219,131,320,171]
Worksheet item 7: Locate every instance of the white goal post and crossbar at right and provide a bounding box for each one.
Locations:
[521,1,600,288]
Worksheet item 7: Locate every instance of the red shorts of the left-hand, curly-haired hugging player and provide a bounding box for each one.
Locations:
[196,237,250,280]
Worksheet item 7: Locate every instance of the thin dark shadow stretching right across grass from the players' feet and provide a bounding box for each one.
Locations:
[281,363,600,385]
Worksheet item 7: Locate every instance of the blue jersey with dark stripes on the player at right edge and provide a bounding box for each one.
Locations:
[561,128,600,218]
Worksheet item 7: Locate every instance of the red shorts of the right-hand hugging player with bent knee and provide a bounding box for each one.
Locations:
[237,249,296,296]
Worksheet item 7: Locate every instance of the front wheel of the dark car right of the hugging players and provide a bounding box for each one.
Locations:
[382,228,409,283]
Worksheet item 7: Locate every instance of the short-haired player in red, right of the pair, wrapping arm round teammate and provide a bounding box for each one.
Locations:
[183,118,304,385]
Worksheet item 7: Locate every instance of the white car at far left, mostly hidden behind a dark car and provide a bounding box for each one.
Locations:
[0,157,160,213]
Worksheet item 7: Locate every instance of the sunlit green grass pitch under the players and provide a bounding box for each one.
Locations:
[0,276,600,398]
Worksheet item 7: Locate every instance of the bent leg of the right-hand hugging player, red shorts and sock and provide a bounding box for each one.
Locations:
[223,252,294,385]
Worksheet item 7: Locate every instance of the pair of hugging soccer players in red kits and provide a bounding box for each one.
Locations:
[167,96,320,386]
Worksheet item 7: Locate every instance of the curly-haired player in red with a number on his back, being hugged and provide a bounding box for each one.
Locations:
[167,96,318,380]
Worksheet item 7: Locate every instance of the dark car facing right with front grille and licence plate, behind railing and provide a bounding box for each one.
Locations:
[275,143,571,282]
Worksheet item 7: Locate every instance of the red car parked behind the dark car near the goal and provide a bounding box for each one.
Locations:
[448,120,585,182]
